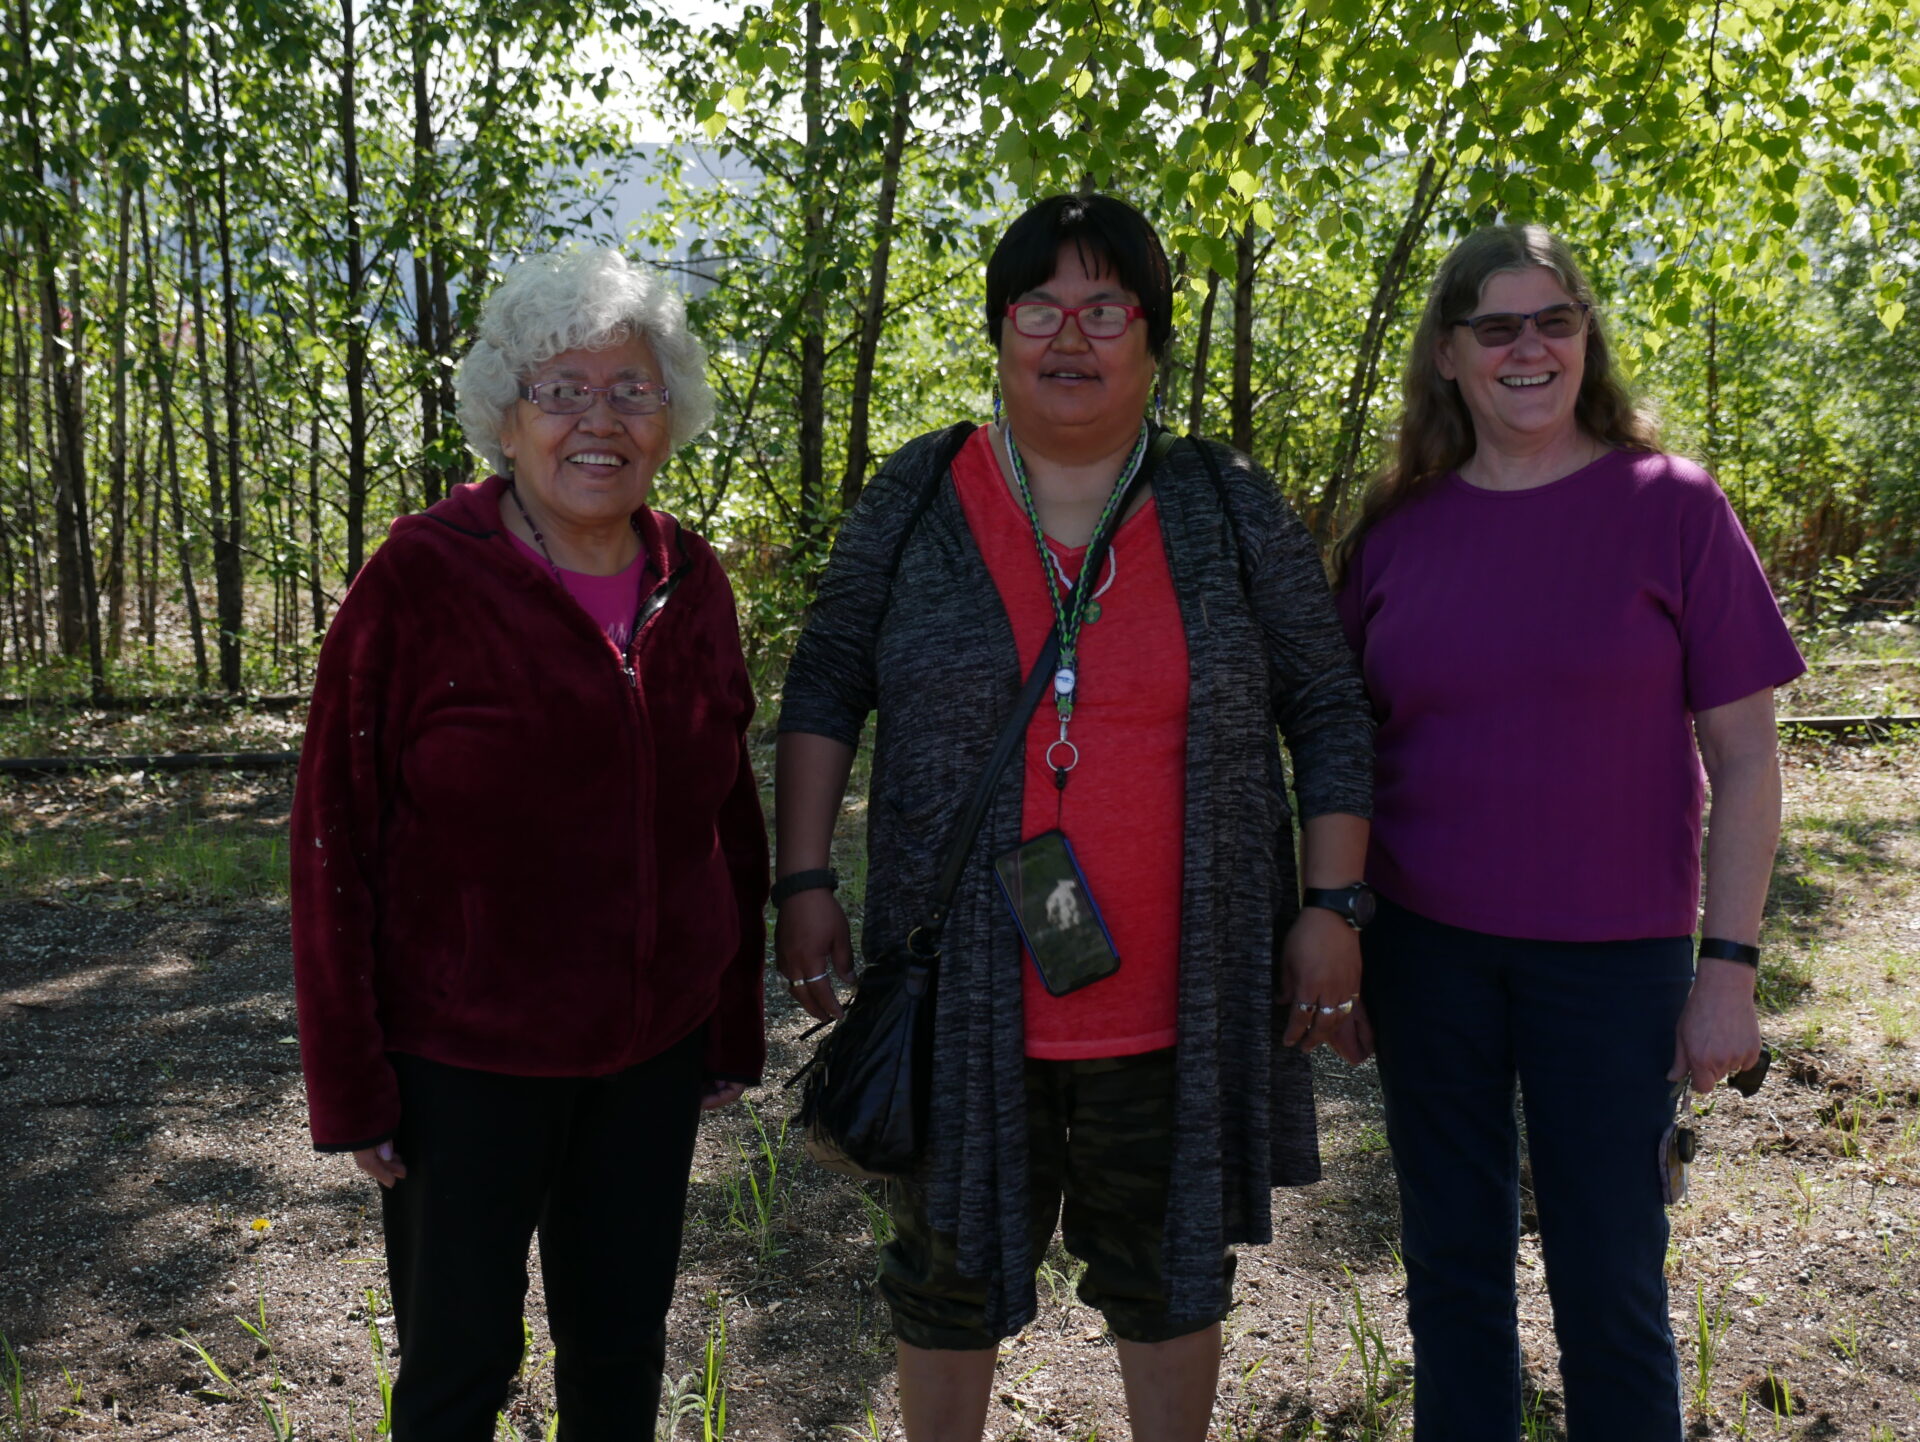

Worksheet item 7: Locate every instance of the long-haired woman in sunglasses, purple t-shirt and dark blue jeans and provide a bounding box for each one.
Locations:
[1336,225,1803,1442]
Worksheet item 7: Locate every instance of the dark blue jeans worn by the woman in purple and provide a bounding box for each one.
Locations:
[1365,904,1693,1442]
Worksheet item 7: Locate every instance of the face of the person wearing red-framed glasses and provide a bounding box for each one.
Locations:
[1000,244,1154,461]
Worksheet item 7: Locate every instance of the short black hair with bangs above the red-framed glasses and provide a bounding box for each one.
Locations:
[987,196,1173,361]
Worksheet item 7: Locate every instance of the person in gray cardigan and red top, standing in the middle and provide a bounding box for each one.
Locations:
[774,196,1371,1442]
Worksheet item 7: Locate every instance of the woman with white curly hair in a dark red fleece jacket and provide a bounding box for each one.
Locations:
[292,250,766,1442]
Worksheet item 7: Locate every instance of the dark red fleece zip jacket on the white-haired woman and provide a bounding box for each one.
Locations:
[290,476,768,1150]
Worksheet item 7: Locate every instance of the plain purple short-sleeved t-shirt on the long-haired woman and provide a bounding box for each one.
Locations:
[1338,451,1805,941]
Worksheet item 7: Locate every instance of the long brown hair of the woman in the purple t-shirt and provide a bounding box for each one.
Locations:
[1332,225,1659,586]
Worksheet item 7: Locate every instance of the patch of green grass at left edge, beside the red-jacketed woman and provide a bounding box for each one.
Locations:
[0,816,286,904]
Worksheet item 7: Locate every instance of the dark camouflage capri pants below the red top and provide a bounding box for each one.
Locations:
[879,1046,1235,1350]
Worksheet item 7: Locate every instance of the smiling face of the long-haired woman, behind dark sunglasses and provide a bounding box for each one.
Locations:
[1434,265,1590,451]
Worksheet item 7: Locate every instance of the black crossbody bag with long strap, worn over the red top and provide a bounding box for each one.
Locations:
[787,432,1173,1177]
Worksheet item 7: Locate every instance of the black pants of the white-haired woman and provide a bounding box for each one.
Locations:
[382,1031,703,1442]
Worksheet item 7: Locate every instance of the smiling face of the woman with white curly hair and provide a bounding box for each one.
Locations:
[499,338,672,534]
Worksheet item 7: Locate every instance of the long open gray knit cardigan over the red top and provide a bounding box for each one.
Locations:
[780,428,1373,1334]
